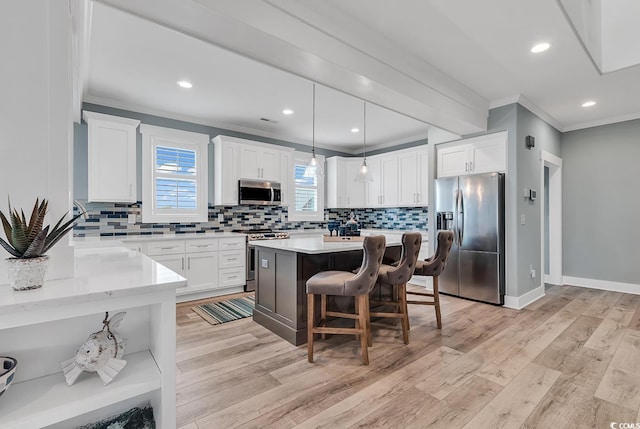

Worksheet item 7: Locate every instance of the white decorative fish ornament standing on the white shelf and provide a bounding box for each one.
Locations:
[60,312,127,386]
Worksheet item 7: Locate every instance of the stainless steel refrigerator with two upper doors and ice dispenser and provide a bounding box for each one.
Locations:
[435,173,505,304]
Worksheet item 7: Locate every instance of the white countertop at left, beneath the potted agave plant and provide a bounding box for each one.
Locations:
[0,247,187,315]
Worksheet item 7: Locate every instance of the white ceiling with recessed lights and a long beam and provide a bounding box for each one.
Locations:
[83,0,640,152]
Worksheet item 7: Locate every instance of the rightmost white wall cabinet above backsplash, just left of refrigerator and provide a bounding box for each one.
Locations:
[398,149,429,207]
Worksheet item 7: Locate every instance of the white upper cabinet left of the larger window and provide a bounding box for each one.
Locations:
[82,111,140,202]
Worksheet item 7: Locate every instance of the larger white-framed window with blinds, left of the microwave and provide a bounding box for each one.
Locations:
[140,124,209,223]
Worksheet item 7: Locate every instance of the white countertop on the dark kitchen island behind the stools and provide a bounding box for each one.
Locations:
[249,234,402,254]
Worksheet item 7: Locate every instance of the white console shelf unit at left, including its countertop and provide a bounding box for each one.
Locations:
[0,247,186,429]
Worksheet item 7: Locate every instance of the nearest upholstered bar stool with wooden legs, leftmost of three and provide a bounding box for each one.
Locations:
[307,235,386,365]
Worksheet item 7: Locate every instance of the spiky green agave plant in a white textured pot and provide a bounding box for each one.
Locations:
[0,199,82,290]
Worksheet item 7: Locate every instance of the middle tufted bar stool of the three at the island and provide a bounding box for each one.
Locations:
[370,232,422,344]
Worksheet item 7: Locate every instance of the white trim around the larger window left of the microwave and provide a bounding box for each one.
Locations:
[140,124,209,223]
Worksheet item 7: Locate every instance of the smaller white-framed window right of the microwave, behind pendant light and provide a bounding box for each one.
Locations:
[289,153,324,221]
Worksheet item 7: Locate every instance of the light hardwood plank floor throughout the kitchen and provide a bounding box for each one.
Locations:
[177,285,640,429]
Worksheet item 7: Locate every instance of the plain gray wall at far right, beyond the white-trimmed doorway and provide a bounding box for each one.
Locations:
[562,120,640,284]
